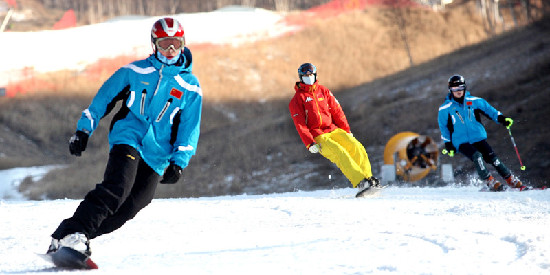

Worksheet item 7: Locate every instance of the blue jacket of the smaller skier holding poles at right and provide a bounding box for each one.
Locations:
[437,91,501,148]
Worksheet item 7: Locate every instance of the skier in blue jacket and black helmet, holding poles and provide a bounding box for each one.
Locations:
[437,75,525,191]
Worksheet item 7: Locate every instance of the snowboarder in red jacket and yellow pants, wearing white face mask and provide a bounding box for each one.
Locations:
[288,63,380,197]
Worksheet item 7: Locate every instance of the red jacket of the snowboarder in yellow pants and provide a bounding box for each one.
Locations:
[288,81,350,148]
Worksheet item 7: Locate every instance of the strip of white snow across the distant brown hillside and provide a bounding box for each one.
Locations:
[0,7,297,87]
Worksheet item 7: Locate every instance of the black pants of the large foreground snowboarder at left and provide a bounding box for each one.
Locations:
[52,145,160,239]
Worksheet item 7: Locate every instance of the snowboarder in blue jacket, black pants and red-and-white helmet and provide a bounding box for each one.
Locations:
[48,18,202,256]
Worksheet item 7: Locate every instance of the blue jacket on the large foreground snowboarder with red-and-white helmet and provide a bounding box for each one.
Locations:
[77,48,202,175]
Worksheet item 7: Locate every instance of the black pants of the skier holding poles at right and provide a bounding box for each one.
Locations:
[458,139,512,180]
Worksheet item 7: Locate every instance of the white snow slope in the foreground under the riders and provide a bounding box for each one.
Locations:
[0,186,550,275]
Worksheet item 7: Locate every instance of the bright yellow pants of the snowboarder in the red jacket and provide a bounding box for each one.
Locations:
[315,128,372,187]
